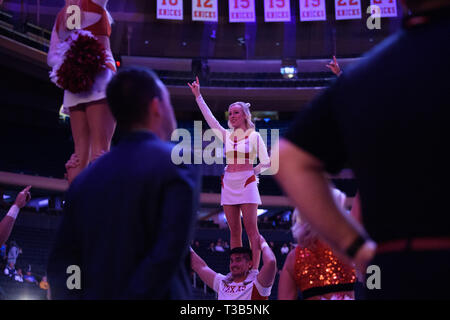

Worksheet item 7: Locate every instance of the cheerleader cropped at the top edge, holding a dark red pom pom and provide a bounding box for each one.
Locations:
[47,0,116,183]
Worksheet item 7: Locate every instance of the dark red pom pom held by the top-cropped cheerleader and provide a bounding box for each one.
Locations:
[51,31,106,93]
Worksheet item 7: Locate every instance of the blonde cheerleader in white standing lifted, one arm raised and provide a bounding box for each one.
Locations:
[188,78,270,269]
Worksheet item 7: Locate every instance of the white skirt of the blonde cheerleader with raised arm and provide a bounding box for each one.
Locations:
[220,170,261,205]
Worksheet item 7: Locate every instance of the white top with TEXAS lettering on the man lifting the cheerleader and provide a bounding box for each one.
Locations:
[213,271,272,300]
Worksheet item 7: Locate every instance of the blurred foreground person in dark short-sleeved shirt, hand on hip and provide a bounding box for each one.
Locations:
[277,0,450,299]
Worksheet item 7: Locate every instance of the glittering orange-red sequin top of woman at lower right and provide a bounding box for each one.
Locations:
[294,240,356,299]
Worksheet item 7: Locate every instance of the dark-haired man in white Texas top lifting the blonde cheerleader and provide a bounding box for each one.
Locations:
[191,236,277,300]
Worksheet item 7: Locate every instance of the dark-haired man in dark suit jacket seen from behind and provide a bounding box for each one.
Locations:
[48,68,200,299]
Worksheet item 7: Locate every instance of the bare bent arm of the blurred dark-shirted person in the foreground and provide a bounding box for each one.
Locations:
[276,139,376,272]
